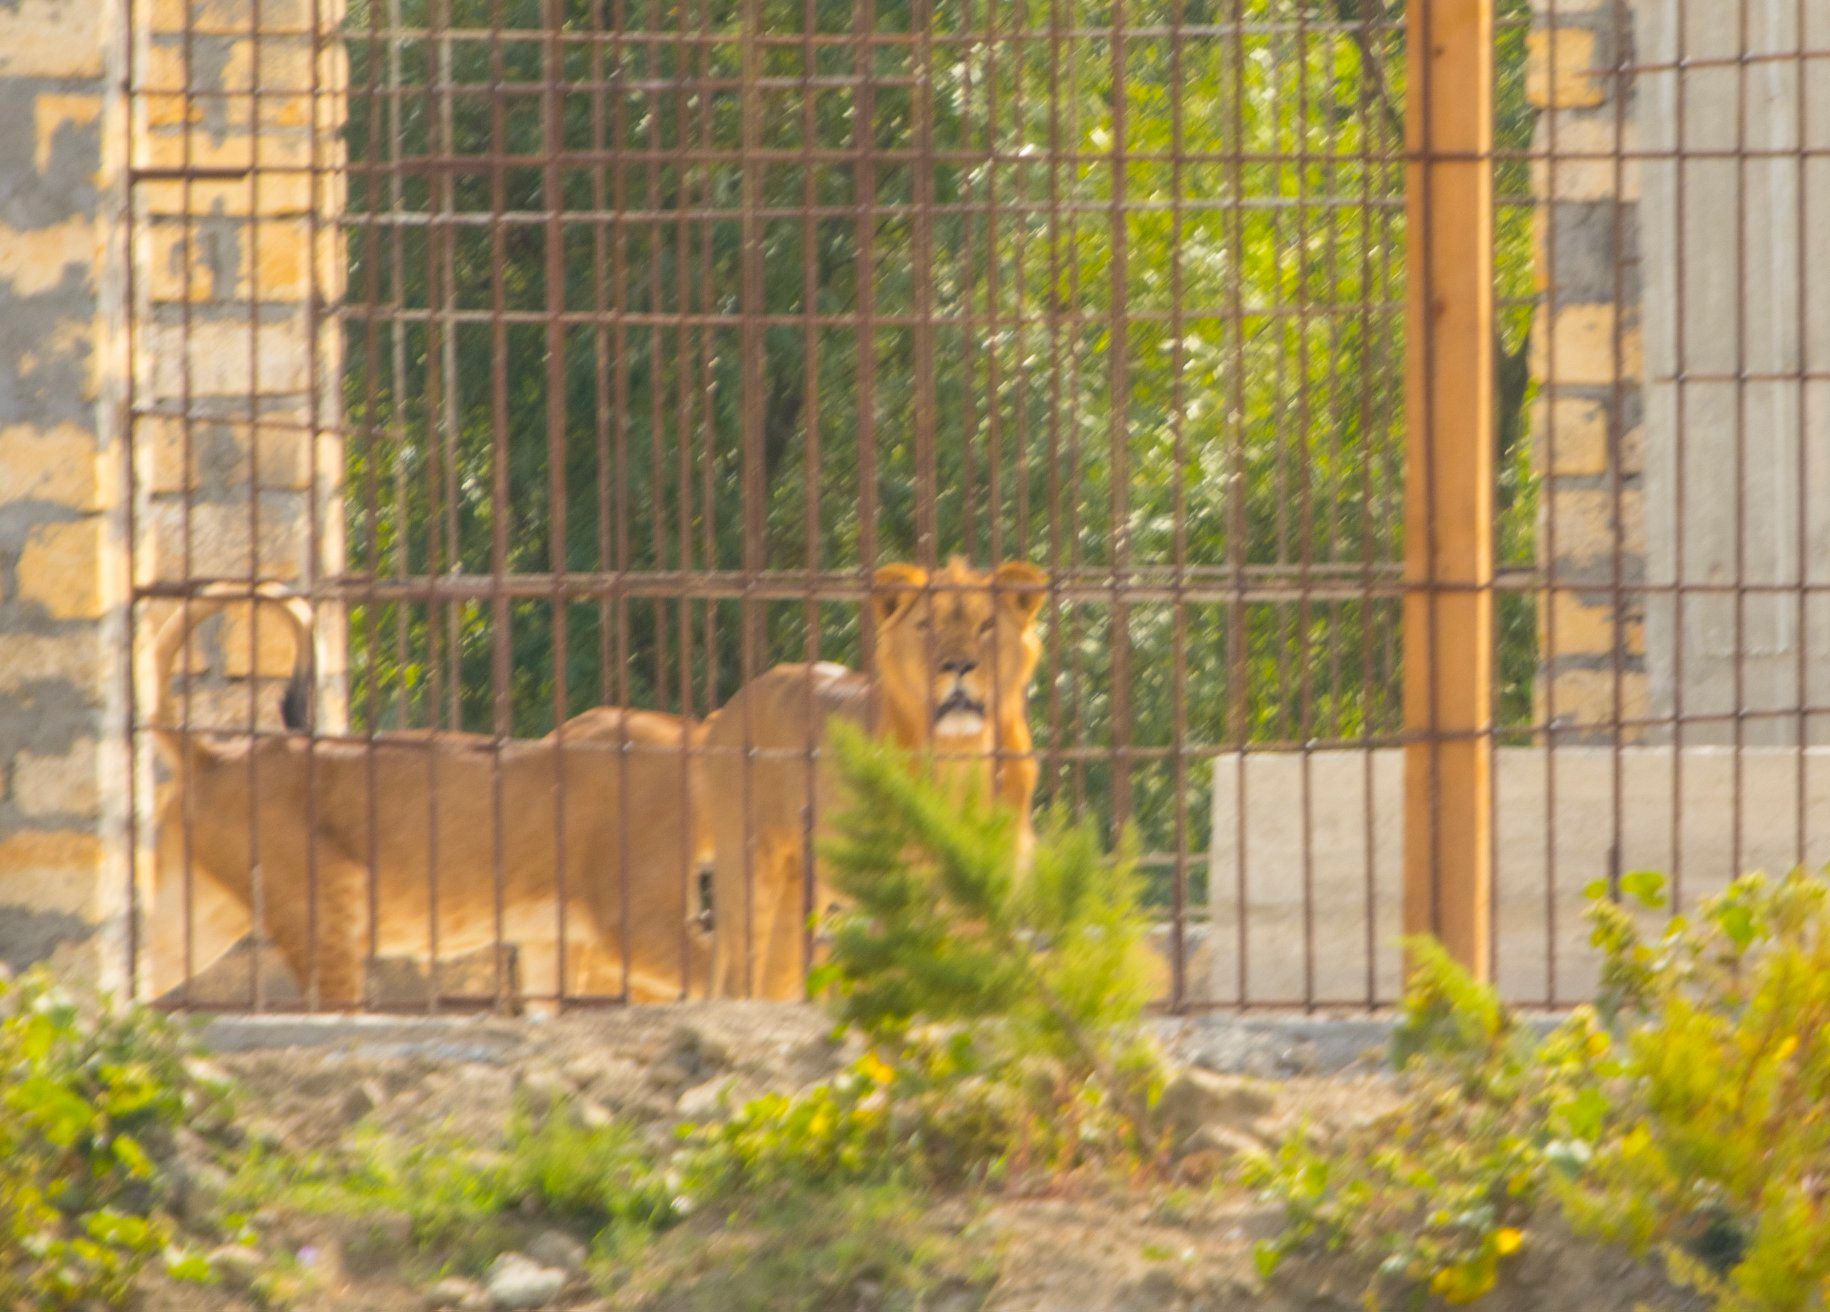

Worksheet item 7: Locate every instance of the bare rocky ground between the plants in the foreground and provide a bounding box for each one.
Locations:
[129,1005,1671,1312]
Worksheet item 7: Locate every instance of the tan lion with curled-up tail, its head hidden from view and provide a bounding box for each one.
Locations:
[140,584,710,1010]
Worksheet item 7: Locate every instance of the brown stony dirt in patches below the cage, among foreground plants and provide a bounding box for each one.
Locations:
[145,1003,1684,1312]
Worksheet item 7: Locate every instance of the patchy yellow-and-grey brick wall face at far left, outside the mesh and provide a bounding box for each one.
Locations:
[0,0,126,970]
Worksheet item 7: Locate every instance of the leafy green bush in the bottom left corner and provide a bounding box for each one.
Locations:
[0,970,225,1308]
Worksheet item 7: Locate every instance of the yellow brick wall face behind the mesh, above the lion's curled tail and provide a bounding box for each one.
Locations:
[134,0,346,728]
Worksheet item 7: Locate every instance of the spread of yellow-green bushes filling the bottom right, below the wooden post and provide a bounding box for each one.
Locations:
[1252,873,1830,1312]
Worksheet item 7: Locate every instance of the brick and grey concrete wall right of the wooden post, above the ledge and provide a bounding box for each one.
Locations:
[1530,0,1830,747]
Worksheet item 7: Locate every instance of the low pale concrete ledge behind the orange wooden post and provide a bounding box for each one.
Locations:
[1195,747,1830,1005]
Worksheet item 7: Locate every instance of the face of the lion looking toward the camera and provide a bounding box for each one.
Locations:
[871,558,1049,748]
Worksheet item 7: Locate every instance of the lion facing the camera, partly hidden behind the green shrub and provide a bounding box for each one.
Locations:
[705,558,1047,1001]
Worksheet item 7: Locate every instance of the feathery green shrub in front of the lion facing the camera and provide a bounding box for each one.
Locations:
[818,725,1160,1164]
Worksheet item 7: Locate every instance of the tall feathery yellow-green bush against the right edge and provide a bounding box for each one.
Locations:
[1566,873,1830,1312]
